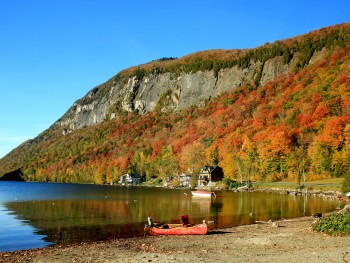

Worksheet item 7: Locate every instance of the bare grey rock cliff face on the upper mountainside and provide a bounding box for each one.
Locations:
[54,51,312,133]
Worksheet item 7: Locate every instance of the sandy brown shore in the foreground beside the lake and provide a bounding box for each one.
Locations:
[0,217,350,263]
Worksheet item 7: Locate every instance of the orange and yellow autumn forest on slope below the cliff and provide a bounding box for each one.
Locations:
[0,24,350,184]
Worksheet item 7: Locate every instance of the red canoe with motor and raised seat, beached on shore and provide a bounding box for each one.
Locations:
[144,215,208,236]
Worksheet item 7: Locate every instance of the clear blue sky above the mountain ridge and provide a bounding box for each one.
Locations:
[0,0,350,158]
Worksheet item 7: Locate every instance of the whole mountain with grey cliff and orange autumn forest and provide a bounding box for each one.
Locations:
[0,24,350,183]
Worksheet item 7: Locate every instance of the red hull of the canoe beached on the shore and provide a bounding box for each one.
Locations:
[145,224,208,236]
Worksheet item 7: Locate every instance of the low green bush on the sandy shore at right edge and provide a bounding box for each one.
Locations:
[312,212,350,236]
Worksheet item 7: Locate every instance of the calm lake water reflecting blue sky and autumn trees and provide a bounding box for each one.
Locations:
[0,182,339,252]
